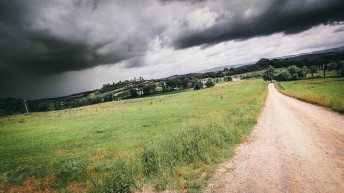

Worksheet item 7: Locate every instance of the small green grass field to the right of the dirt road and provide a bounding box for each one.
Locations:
[277,78,344,113]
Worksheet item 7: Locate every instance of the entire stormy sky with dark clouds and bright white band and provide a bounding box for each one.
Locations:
[0,0,344,99]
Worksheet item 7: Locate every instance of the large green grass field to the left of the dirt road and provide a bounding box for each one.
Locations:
[0,80,267,192]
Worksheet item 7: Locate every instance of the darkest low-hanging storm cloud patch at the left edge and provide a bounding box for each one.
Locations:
[0,33,119,75]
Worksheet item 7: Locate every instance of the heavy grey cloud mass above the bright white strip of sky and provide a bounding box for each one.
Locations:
[0,0,344,75]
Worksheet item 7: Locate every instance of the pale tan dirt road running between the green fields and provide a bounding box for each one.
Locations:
[205,84,344,193]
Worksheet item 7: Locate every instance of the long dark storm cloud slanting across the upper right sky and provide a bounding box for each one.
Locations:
[173,0,344,49]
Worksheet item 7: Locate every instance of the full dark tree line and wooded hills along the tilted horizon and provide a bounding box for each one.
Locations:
[0,53,344,115]
